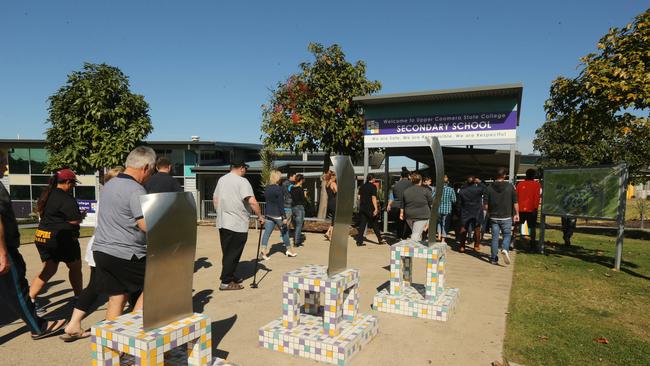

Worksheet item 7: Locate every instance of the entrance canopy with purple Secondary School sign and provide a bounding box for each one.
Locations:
[354,83,523,183]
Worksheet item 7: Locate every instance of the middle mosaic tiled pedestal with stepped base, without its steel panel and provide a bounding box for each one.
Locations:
[259,265,379,366]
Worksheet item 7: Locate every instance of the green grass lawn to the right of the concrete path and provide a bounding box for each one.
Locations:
[504,230,650,366]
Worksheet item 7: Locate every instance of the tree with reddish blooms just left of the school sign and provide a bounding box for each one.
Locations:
[262,43,381,217]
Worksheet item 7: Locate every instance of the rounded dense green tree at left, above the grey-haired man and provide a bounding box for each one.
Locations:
[46,63,153,180]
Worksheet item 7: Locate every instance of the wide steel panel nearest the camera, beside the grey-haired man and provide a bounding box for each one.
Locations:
[140,192,196,330]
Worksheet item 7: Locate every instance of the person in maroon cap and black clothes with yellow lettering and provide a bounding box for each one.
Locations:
[29,169,85,309]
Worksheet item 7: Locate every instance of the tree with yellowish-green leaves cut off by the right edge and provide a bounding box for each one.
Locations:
[533,10,650,182]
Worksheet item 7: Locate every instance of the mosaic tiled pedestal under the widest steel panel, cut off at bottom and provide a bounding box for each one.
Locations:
[91,311,225,366]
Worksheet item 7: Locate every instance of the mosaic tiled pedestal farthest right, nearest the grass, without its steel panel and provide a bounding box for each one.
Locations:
[373,239,459,321]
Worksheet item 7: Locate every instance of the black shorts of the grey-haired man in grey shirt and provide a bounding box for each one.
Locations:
[93,251,147,296]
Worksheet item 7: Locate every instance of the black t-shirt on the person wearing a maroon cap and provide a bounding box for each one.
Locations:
[39,188,83,239]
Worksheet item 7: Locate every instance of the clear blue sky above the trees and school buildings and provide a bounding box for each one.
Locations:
[0,0,647,153]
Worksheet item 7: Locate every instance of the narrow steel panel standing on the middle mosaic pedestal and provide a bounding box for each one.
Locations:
[327,155,355,276]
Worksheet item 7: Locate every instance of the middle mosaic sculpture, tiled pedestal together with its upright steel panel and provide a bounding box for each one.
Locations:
[259,156,378,366]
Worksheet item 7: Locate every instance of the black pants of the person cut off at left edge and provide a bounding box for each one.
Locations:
[0,248,46,334]
